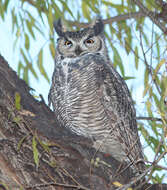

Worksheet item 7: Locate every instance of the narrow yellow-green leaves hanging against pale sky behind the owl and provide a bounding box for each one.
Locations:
[0,0,167,183]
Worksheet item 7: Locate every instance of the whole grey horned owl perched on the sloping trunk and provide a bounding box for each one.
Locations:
[49,19,143,174]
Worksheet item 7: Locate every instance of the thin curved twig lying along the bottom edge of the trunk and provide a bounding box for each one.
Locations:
[25,182,90,190]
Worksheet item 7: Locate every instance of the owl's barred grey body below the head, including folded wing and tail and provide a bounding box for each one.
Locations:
[50,54,143,172]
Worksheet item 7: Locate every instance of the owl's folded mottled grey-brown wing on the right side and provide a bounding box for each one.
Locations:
[96,60,143,167]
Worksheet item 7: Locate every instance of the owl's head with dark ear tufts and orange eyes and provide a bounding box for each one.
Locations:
[54,18,106,58]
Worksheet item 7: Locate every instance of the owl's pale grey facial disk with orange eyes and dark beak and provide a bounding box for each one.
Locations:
[58,35,102,57]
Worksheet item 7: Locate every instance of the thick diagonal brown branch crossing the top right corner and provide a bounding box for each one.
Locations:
[132,0,167,34]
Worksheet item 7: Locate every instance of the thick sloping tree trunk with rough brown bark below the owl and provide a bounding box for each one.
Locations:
[0,56,167,190]
